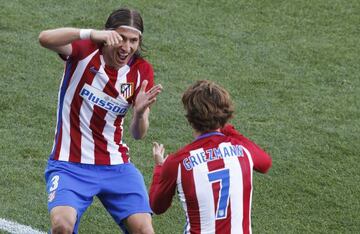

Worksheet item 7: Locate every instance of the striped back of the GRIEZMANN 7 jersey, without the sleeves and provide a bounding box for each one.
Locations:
[177,132,253,234]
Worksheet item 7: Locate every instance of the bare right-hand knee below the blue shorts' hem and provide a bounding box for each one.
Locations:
[124,213,154,234]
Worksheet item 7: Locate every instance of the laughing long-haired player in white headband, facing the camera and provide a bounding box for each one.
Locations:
[39,8,162,233]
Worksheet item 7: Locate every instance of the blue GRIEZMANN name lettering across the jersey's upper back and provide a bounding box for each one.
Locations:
[183,143,244,171]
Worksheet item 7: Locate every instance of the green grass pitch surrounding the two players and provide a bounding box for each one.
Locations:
[0,0,360,234]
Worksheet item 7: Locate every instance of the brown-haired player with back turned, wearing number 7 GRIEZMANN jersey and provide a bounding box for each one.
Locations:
[150,80,271,234]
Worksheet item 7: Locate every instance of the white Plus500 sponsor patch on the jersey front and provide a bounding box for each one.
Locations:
[80,84,130,115]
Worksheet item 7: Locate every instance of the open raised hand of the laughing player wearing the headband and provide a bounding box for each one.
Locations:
[134,80,162,114]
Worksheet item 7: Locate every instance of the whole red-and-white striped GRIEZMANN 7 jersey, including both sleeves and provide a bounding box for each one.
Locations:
[150,125,271,234]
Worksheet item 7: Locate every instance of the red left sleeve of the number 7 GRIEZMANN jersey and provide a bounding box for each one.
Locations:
[149,156,178,214]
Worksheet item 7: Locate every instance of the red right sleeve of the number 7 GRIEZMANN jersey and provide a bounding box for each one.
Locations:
[221,124,272,173]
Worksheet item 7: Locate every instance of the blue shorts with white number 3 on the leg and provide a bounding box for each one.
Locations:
[45,160,152,233]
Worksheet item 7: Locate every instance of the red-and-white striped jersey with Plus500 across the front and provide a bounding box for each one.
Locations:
[50,40,154,165]
